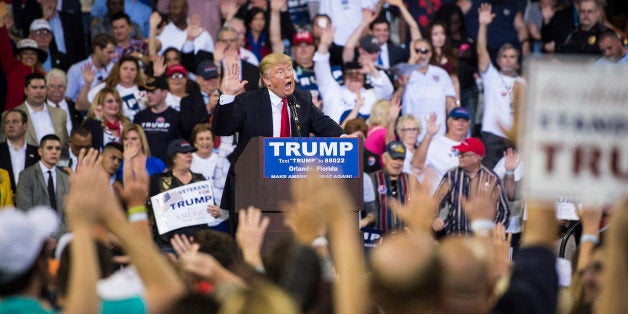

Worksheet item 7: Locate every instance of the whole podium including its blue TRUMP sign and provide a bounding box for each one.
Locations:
[235,137,364,243]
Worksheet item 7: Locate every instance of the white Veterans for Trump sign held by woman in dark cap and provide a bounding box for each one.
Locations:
[150,181,216,234]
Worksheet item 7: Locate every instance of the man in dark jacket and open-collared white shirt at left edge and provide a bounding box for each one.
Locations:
[0,109,39,191]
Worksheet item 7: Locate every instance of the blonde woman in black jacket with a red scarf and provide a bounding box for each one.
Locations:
[83,87,131,150]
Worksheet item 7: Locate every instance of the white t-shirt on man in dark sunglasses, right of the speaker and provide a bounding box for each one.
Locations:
[402,65,456,143]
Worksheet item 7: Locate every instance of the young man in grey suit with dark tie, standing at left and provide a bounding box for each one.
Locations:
[16,134,70,238]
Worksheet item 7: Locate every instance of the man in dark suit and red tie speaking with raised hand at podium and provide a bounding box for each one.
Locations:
[212,52,344,232]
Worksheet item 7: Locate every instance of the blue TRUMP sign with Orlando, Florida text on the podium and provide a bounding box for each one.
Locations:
[264,137,360,179]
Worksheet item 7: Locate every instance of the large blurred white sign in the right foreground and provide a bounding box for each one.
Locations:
[519,60,628,205]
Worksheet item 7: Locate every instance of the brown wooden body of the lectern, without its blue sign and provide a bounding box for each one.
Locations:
[235,137,364,243]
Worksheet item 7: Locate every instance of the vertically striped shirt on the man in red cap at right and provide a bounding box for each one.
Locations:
[436,166,510,234]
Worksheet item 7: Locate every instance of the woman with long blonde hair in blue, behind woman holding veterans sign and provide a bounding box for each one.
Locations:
[116,123,166,180]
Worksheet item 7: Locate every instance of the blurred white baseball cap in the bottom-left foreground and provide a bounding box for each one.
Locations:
[0,206,59,283]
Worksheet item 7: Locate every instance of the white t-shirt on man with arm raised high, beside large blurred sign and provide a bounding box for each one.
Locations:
[480,64,523,137]
